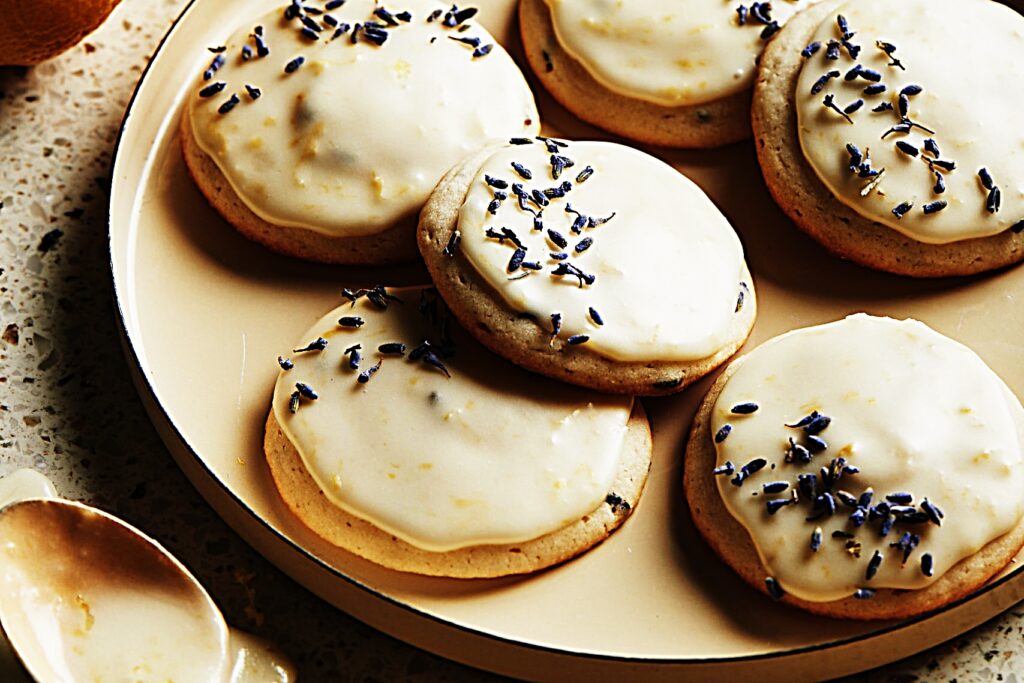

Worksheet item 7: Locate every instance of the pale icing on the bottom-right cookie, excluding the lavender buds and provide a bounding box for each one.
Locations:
[712,314,1024,601]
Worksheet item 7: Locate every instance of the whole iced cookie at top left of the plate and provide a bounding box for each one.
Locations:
[181,0,540,264]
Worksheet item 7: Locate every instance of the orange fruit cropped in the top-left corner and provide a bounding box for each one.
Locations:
[0,0,120,67]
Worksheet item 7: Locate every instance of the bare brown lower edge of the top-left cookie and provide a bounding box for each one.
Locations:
[179,106,417,265]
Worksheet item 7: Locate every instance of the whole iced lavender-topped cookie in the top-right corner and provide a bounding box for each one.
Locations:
[753,0,1024,278]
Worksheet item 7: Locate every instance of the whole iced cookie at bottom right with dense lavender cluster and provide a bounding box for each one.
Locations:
[685,314,1024,618]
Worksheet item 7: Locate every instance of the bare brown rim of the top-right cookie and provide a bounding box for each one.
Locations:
[752,0,1024,278]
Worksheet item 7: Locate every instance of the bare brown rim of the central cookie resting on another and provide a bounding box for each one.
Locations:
[418,148,757,396]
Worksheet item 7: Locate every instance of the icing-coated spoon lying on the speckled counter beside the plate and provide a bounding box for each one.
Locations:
[0,475,295,683]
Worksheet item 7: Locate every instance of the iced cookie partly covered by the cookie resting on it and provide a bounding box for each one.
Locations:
[264,289,651,579]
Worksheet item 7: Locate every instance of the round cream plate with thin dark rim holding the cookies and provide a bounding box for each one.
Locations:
[111,0,1024,681]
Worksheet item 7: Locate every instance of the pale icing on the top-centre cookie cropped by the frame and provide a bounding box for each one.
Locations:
[545,0,816,106]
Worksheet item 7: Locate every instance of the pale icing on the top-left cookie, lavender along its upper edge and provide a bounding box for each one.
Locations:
[188,0,540,237]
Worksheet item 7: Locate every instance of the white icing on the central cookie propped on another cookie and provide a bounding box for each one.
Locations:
[459,142,751,361]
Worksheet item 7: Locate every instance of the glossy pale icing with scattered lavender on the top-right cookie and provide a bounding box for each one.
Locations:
[796,0,1024,244]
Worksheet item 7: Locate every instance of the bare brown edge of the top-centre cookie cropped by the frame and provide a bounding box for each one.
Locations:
[519,0,751,147]
